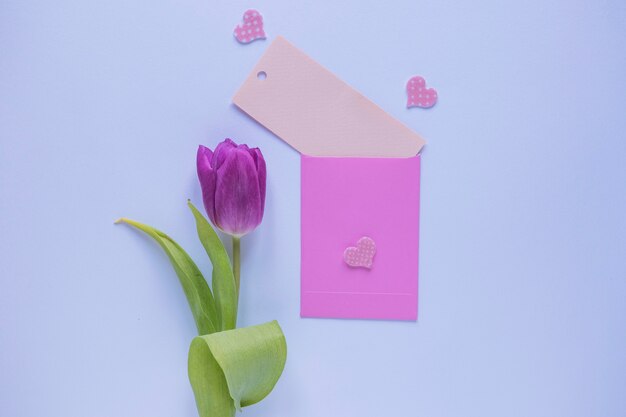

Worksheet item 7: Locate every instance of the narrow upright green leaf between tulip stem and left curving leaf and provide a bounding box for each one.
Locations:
[187,201,238,330]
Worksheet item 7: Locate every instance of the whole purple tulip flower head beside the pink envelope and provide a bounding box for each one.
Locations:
[197,139,266,238]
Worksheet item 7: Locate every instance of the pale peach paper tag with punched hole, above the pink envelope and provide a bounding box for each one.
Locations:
[233,36,425,158]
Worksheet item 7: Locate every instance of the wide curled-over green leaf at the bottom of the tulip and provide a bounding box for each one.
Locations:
[189,321,287,417]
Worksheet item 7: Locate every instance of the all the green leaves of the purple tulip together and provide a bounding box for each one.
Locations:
[116,206,287,417]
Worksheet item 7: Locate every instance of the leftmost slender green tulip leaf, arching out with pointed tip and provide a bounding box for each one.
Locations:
[116,218,219,334]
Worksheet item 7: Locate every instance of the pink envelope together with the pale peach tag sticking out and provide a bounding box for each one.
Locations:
[233,37,425,320]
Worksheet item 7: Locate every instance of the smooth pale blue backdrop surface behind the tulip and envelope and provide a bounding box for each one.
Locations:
[0,0,626,417]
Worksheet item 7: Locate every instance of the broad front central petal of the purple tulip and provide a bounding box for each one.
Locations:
[215,149,263,236]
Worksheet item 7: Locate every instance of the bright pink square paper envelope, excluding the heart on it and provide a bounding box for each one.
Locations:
[300,156,420,320]
